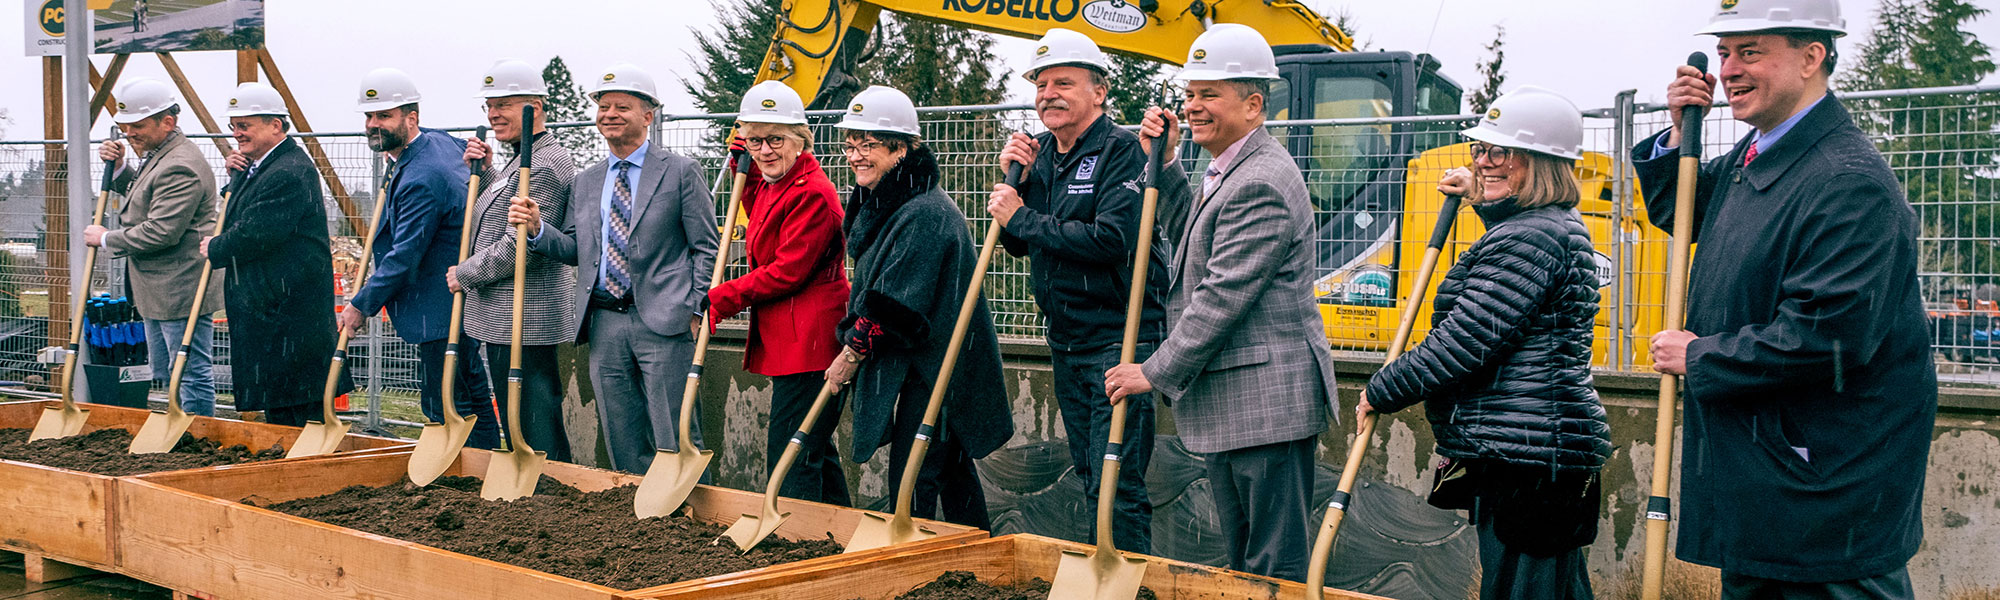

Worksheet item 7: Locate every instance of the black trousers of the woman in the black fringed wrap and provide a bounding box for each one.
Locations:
[888,378,992,530]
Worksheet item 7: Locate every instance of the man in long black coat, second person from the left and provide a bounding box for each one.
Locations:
[202,82,354,426]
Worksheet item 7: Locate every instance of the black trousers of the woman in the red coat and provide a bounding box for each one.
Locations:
[764,372,854,506]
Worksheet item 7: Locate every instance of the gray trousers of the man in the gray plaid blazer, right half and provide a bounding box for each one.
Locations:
[1206,438,1320,582]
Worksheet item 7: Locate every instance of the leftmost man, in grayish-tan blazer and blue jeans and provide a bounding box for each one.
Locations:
[84,80,222,416]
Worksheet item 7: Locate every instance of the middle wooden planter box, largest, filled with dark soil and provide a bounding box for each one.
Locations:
[118,448,988,600]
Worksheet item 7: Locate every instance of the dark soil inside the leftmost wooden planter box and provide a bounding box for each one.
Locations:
[0,430,284,476]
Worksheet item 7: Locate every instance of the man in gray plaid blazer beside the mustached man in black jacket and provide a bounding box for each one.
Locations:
[1104,24,1338,580]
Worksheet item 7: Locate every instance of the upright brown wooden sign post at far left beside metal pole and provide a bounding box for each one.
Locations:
[42,56,69,352]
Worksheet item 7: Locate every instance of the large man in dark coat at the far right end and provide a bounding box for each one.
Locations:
[1634,0,1938,598]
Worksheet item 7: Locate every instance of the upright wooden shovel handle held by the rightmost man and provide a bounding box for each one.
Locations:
[1640,52,1708,600]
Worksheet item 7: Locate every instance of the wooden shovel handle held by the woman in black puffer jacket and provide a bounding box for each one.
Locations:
[1306,196,1460,600]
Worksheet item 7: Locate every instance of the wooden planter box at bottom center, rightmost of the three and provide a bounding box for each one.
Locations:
[640,534,1382,600]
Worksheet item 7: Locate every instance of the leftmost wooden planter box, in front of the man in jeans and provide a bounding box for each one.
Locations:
[0,400,410,572]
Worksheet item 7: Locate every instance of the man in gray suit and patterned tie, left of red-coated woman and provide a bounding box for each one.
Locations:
[508,64,720,472]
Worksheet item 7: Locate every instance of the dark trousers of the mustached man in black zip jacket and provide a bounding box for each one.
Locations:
[1048,344,1154,554]
